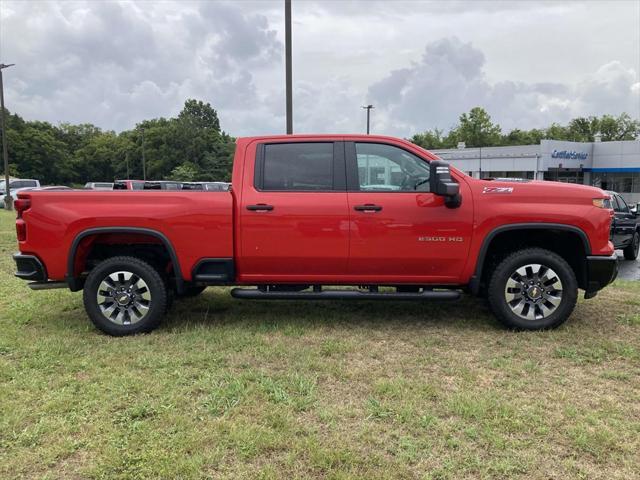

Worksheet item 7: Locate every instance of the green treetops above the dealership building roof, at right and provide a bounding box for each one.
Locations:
[409,107,640,150]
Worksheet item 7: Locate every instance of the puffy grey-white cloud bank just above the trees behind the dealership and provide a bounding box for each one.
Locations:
[368,37,640,135]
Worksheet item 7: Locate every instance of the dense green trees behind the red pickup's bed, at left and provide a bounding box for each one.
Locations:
[5,99,235,185]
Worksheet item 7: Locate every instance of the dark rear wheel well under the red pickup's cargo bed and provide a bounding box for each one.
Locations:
[68,231,180,288]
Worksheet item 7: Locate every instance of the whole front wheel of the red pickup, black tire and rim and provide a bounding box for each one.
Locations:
[488,248,578,330]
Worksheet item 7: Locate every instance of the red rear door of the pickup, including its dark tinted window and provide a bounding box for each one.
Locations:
[237,141,349,283]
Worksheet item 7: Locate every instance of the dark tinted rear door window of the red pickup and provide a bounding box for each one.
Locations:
[262,143,333,191]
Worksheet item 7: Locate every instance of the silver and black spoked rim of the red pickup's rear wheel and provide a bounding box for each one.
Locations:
[97,271,151,325]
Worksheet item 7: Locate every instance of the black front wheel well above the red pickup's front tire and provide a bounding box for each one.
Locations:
[480,228,590,291]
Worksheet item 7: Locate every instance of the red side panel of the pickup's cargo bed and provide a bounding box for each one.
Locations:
[19,190,233,280]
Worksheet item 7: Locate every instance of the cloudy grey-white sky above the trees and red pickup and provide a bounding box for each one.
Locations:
[0,0,640,137]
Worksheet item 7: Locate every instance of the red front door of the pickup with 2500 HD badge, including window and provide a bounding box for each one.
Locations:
[345,142,473,284]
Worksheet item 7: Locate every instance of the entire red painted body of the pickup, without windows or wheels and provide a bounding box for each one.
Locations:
[19,135,613,285]
